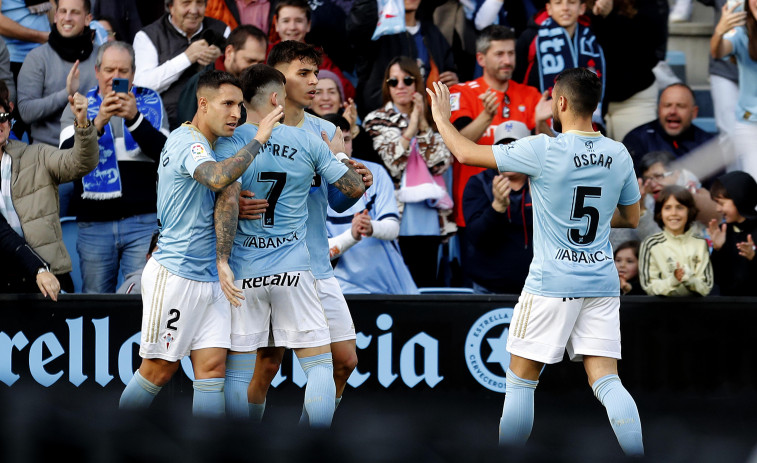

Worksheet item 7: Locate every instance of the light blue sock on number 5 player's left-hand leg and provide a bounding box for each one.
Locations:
[499,368,539,446]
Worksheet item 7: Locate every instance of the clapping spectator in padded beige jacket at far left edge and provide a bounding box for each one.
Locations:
[0,93,98,293]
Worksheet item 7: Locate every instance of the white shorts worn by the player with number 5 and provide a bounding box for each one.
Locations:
[507,291,620,363]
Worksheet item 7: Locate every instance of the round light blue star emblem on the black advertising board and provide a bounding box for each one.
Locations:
[465,307,513,393]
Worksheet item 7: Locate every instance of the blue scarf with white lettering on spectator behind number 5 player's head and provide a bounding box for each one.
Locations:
[535,16,605,122]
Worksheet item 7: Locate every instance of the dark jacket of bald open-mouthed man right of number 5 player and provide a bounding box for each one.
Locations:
[623,119,714,167]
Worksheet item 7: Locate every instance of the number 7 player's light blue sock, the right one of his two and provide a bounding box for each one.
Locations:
[299,353,336,428]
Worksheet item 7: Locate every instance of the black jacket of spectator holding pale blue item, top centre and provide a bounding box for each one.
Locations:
[347,0,456,117]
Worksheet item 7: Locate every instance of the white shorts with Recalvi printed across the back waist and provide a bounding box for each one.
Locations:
[231,270,331,352]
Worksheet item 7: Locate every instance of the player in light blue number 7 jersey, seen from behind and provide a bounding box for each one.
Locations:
[215,64,365,426]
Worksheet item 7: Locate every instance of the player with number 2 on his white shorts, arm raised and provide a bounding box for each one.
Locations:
[120,71,283,416]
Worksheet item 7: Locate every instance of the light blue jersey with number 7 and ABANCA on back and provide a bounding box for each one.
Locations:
[216,124,347,278]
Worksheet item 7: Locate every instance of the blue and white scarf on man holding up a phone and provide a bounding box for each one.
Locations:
[81,86,163,199]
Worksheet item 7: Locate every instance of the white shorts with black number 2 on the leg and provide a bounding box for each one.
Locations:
[139,259,231,362]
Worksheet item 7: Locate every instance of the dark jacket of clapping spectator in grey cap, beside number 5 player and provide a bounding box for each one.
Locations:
[463,169,534,294]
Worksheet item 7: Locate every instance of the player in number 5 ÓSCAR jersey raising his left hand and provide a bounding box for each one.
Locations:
[428,68,644,455]
